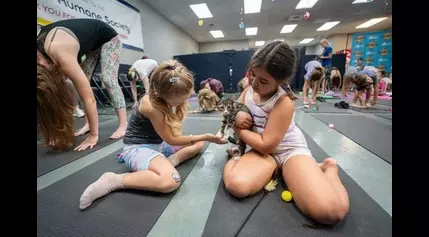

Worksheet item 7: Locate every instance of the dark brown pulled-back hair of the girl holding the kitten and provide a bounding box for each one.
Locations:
[249,40,297,100]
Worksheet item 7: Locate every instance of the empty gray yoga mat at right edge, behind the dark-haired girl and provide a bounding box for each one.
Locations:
[312,114,392,164]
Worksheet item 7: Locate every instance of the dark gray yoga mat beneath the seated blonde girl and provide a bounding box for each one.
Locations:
[37,121,218,237]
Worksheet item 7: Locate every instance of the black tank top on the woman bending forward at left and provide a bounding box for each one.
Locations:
[37,19,118,63]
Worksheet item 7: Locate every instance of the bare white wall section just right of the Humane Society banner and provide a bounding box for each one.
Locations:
[120,0,199,64]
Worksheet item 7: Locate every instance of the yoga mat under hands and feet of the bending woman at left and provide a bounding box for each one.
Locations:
[37,118,118,177]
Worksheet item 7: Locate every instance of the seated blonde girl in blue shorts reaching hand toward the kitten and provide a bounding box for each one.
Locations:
[79,60,227,210]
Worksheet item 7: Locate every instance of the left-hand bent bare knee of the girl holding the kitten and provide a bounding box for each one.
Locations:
[223,150,277,198]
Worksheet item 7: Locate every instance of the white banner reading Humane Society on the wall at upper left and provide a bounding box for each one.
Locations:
[37,0,144,51]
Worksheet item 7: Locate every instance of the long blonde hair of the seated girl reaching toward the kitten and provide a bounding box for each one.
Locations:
[149,60,194,136]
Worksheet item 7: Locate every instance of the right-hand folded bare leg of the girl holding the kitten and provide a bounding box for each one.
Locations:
[282,155,349,224]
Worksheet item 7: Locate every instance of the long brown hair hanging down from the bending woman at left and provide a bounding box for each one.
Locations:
[37,64,75,150]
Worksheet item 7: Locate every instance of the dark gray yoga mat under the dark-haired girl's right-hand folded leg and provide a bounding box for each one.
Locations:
[236,129,392,237]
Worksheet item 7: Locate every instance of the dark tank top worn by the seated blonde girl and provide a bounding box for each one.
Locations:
[123,103,163,145]
